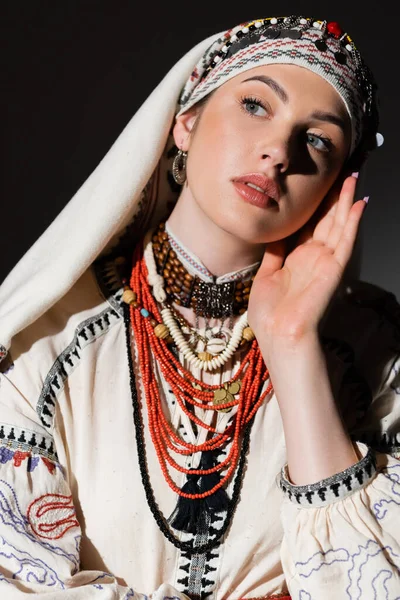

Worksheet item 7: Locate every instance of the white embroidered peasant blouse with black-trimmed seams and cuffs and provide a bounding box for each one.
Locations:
[0,232,400,600]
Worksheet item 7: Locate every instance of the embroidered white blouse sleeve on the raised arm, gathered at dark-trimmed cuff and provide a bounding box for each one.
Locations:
[278,357,400,600]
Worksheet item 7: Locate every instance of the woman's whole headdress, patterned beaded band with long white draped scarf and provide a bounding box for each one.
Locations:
[0,17,377,361]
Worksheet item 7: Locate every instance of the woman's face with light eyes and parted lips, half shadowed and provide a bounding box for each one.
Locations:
[174,65,350,243]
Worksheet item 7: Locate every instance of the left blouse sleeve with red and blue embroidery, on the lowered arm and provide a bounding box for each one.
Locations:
[0,366,187,600]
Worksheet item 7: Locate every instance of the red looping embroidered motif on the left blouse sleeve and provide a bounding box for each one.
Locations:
[27,494,79,540]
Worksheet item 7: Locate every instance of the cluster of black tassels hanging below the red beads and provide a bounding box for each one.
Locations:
[168,450,230,534]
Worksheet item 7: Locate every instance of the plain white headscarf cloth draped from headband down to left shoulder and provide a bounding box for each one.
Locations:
[0,33,221,360]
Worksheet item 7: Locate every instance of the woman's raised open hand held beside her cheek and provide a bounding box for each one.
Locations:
[248,177,366,341]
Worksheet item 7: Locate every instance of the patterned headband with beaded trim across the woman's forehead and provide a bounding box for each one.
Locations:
[176,16,383,157]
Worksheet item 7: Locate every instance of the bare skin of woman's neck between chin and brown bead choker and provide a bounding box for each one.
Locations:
[168,188,265,277]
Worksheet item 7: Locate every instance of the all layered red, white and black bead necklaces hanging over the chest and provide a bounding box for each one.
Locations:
[117,225,272,554]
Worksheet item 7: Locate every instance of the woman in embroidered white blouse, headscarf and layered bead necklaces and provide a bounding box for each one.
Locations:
[0,12,400,600]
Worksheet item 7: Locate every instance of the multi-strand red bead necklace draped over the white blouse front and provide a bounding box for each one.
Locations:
[126,243,272,500]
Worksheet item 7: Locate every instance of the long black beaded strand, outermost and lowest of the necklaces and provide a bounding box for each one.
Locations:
[123,306,254,556]
